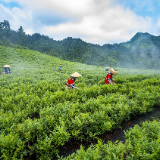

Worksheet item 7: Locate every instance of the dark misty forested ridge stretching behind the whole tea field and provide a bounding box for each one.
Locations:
[0,20,160,69]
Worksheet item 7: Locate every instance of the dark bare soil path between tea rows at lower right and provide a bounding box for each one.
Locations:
[53,106,160,160]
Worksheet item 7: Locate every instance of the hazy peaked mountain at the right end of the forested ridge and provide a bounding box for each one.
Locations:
[120,32,160,68]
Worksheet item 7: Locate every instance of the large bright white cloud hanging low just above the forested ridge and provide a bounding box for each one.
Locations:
[40,2,151,44]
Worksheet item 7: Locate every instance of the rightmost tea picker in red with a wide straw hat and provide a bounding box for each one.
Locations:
[104,67,118,85]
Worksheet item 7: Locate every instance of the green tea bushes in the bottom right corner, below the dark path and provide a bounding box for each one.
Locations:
[62,121,160,160]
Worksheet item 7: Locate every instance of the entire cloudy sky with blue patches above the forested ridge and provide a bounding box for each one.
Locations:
[0,0,160,45]
